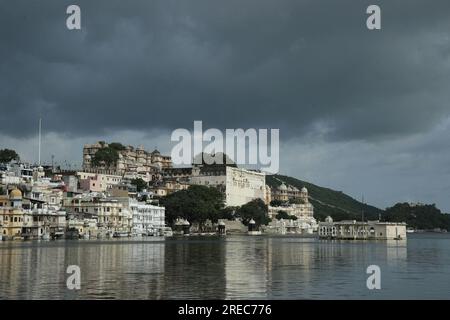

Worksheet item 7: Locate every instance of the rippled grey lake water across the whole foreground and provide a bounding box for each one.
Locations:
[0,234,450,299]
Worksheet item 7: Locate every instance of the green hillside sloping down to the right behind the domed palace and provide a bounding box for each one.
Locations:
[266,175,384,221]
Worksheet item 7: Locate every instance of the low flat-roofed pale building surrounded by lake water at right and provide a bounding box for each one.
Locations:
[318,217,406,240]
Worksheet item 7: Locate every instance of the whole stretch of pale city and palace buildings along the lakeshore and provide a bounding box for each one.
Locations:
[0,142,408,240]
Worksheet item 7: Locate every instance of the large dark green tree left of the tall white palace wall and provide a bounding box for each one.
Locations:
[161,185,225,226]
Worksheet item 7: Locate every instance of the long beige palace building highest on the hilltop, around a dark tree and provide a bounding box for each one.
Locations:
[83,142,172,175]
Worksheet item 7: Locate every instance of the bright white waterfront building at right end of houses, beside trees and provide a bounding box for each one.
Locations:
[129,199,165,235]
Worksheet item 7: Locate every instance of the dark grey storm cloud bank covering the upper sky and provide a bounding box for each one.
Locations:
[0,0,450,141]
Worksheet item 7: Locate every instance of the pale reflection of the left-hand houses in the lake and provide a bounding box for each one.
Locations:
[0,240,165,299]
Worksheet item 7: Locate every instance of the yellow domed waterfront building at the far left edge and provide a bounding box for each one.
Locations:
[0,189,24,239]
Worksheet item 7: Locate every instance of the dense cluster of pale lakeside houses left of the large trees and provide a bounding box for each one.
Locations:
[0,164,169,240]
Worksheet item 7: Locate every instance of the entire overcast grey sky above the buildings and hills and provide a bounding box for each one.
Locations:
[0,0,450,212]
